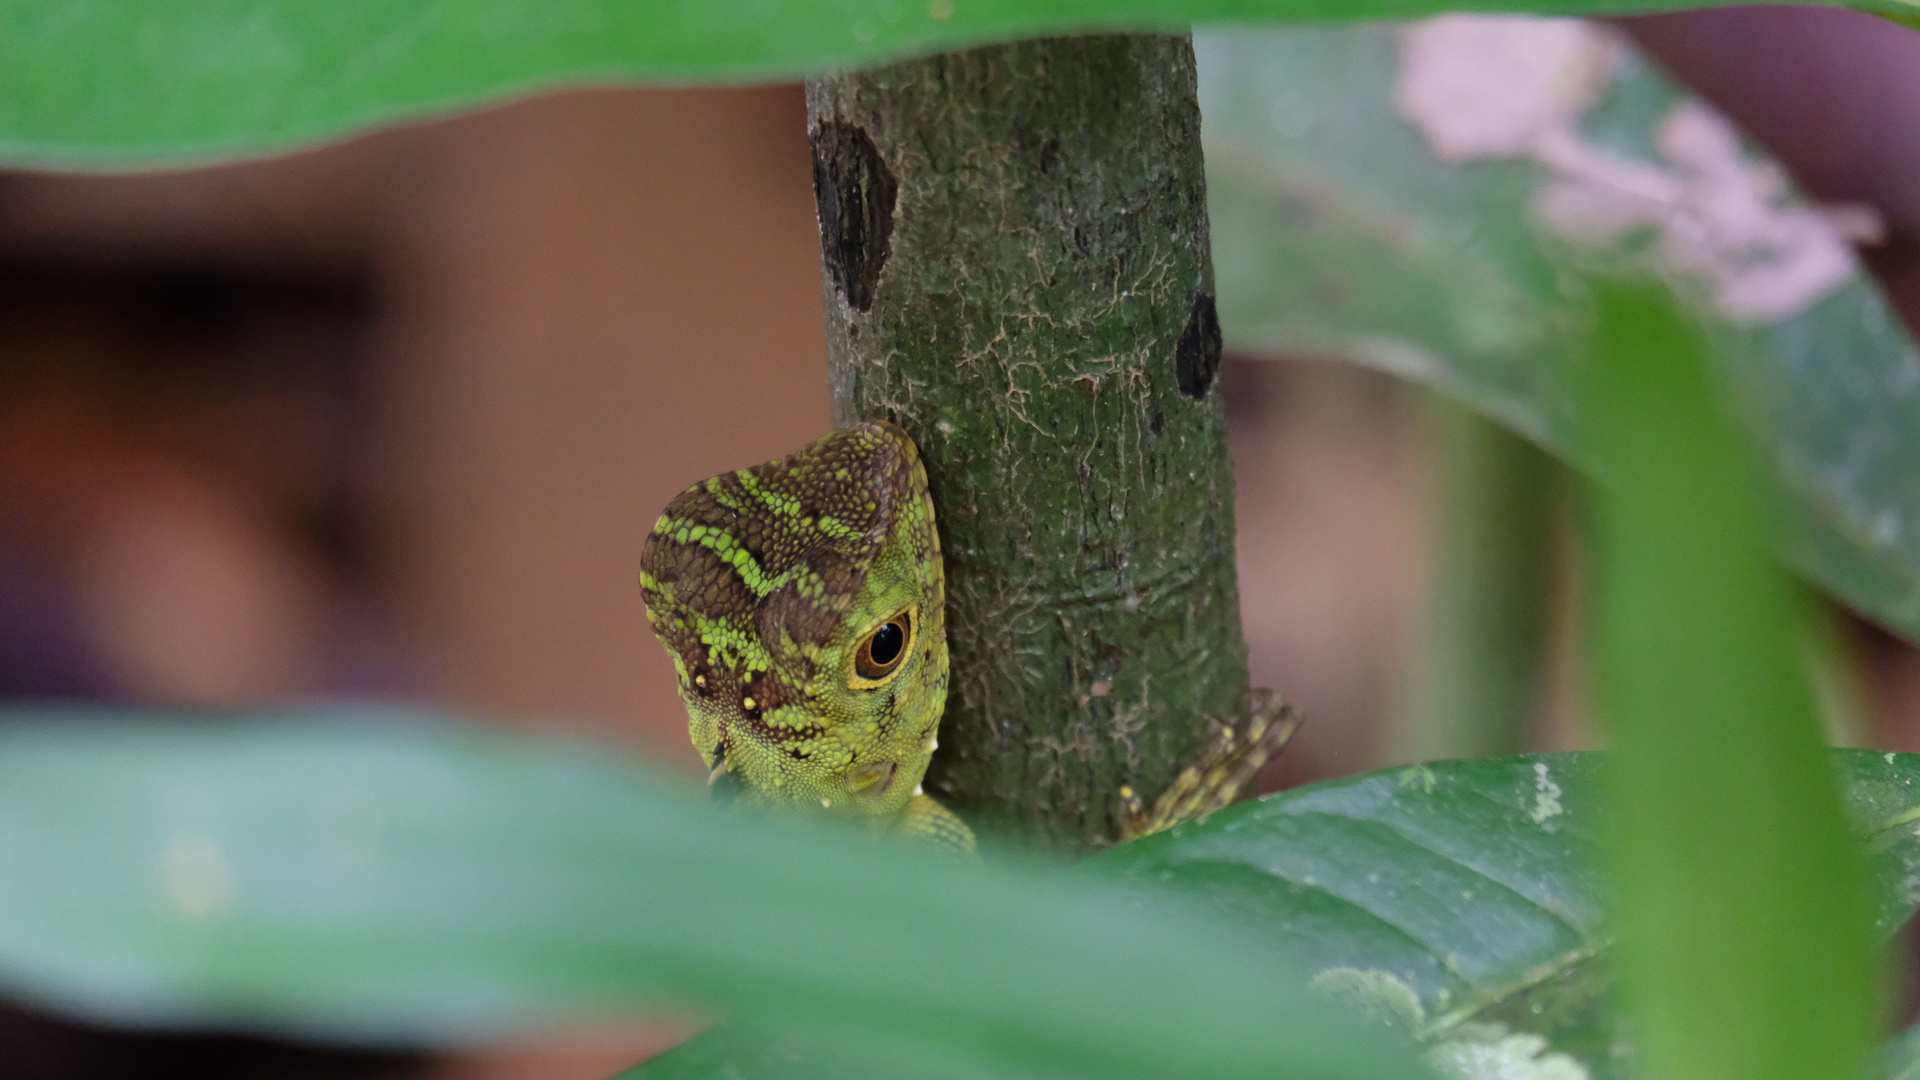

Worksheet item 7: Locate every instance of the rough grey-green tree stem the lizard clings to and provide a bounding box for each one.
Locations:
[806,37,1246,851]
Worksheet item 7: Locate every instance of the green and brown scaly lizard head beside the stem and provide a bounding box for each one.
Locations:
[639,423,947,815]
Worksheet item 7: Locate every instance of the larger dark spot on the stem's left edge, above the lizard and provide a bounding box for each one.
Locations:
[812,119,899,311]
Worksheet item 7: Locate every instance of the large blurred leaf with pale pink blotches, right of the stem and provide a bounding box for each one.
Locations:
[1196,25,1920,638]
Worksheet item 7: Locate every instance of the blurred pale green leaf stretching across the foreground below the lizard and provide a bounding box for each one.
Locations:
[0,709,1411,1080]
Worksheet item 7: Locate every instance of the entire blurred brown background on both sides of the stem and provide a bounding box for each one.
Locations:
[0,10,1920,1080]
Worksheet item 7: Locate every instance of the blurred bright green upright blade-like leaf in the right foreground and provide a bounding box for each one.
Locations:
[1586,284,1878,1080]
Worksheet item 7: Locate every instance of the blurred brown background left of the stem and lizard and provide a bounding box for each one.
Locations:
[0,86,829,1080]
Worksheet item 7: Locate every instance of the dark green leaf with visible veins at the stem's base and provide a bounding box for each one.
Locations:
[636,749,1920,1080]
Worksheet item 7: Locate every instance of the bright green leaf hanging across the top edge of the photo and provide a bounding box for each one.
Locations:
[0,0,1920,167]
